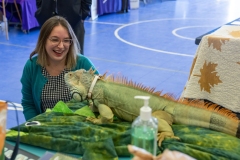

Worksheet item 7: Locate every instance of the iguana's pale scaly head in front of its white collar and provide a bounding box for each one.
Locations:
[64,69,95,101]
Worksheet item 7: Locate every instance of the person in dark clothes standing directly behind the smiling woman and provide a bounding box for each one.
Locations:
[35,0,92,54]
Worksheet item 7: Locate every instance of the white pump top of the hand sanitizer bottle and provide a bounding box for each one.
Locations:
[134,96,152,121]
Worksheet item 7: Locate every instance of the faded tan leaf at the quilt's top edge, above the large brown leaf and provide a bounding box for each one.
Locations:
[208,36,230,52]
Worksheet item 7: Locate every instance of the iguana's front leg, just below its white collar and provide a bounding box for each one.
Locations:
[86,104,113,124]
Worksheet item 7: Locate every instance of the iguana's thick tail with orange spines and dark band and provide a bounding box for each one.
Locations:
[164,100,240,138]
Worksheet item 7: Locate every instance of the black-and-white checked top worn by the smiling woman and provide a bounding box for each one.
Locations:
[41,67,71,112]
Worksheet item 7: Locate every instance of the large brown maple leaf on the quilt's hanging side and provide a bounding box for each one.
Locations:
[194,61,222,93]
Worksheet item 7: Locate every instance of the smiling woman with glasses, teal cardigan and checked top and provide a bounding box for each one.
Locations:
[21,16,98,120]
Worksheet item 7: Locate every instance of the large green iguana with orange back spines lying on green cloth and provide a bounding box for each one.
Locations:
[65,69,240,145]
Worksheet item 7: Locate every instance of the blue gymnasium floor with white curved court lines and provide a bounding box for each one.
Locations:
[0,0,240,128]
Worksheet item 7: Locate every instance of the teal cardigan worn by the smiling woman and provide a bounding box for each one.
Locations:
[21,54,99,120]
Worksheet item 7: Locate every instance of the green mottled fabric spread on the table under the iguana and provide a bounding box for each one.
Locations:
[6,103,240,160]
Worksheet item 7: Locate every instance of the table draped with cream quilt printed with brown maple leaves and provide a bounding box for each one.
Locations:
[182,25,240,113]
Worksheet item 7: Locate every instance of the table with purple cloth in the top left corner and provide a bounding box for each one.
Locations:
[0,0,39,31]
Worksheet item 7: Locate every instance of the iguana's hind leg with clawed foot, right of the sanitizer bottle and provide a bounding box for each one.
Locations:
[152,110,180,146]
